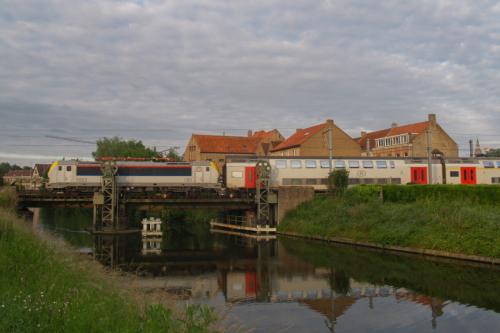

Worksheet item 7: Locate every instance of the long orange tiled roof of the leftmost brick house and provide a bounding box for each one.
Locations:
[193,134,261,154]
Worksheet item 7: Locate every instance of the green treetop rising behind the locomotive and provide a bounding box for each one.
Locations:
[92,136,160,158]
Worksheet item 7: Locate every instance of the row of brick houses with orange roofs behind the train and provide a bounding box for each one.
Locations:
[183,114,458,166]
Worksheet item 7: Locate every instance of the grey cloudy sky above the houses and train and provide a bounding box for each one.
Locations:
[0,0,500,164]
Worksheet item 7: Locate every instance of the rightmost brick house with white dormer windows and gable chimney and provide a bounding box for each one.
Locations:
[357,114,458,157]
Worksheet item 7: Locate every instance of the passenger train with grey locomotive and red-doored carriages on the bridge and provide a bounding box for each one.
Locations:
[47,156,500,194]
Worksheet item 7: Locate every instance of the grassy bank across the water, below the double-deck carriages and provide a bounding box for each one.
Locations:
[279,186,500,258]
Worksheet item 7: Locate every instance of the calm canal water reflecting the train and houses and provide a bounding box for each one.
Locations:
[34,209,500,332]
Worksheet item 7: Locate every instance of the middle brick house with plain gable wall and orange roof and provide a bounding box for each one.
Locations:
[270,119,361,157]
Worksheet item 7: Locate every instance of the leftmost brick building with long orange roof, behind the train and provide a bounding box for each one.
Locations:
[183,129,284,167]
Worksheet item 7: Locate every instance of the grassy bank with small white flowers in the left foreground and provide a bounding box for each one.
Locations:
[0,208,219,332]
